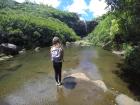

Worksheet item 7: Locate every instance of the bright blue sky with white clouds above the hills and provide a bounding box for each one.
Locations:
[15,0,107,20]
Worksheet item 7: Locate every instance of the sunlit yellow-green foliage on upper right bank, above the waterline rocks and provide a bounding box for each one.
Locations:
[90,0,140,50]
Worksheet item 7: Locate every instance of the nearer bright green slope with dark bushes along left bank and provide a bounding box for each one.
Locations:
[0,8,79,47]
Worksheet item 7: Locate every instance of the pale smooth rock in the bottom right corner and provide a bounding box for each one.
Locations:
[115,94,140,105]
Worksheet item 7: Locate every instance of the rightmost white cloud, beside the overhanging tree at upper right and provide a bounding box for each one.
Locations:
[89,0,107,17]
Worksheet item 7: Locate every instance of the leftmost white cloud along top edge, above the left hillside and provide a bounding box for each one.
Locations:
[15,0,60,8]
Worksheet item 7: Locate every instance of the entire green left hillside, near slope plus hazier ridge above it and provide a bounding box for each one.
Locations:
[0,0,79,48]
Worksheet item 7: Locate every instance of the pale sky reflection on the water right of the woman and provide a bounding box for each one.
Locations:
[77,49,102,80]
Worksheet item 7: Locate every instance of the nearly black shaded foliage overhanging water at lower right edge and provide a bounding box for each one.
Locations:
[121,47,140,99]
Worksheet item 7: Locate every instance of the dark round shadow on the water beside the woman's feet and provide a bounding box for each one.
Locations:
[63,76,77,89]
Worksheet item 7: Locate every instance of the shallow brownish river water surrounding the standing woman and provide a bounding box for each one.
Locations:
[0,47,136,105]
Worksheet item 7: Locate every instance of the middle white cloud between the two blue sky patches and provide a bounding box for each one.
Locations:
[66,0,88,14]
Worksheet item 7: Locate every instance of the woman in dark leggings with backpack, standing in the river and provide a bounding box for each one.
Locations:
[50,37,64,86]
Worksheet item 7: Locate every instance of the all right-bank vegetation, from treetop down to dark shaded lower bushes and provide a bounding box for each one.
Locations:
[89,0,140,99]
